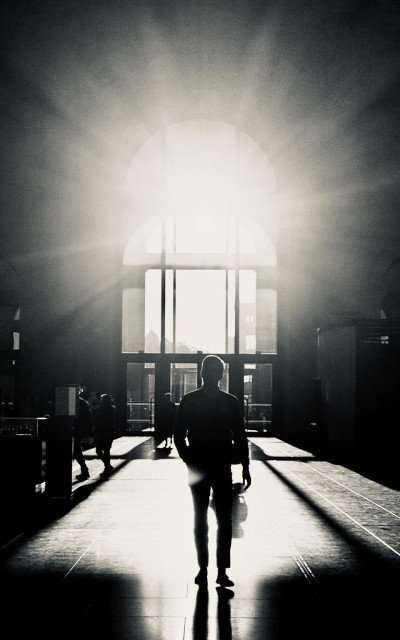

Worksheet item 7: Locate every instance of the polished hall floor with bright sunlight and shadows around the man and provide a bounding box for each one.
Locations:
[0,437,400,640]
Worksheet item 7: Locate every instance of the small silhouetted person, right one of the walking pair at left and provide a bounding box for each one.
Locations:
[93,393,116,477]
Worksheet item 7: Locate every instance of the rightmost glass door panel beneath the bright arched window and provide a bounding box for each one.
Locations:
[244,364,272,434]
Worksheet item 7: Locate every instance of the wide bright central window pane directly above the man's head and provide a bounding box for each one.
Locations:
[176,270,226,353]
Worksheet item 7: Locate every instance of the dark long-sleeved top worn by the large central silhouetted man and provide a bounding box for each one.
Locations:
[174,388,249,468]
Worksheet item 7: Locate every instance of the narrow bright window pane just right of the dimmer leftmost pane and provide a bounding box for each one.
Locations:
[144,269,161,353]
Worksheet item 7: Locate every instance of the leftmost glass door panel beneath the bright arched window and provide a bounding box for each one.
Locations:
[126,362,155,432]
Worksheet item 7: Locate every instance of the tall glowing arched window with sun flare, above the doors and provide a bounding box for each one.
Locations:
[122,121,277,354]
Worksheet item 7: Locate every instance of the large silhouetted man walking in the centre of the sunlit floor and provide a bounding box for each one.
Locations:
[174,355,251,587]
